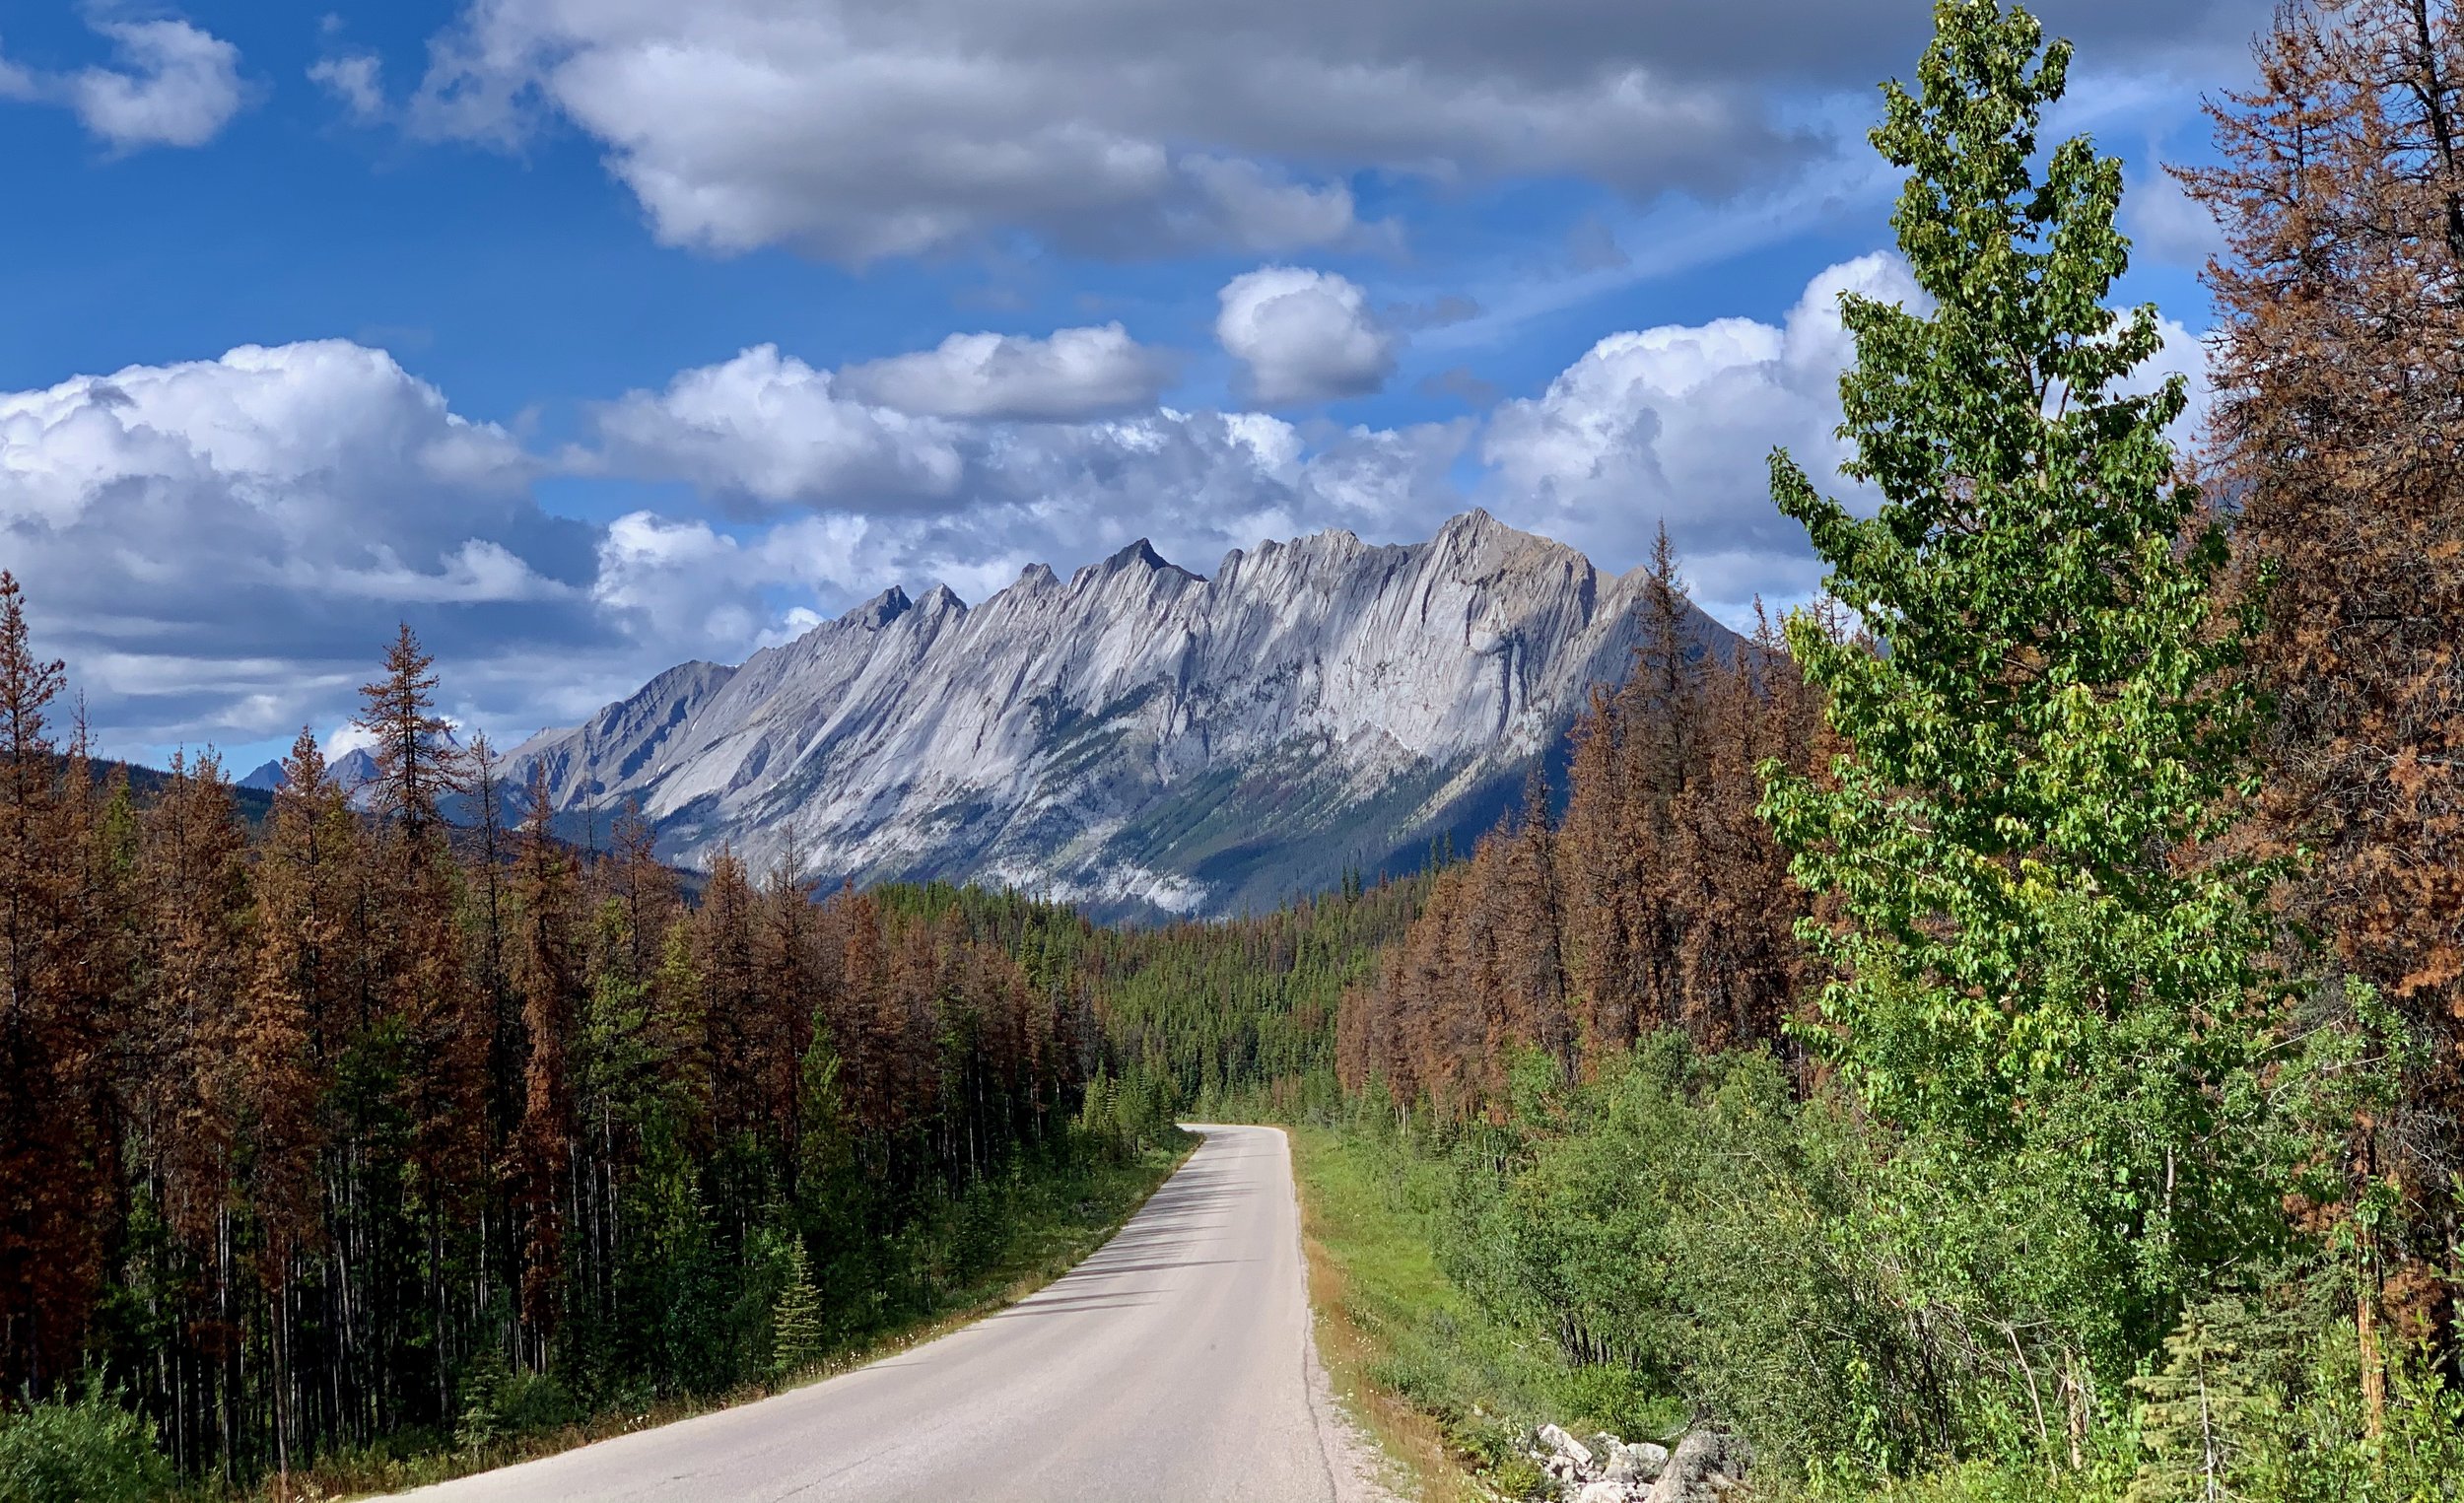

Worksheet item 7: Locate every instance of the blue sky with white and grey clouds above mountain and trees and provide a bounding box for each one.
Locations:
[0,0,2267,764]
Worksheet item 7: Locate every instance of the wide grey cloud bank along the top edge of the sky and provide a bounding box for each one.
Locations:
[394,0,2267,264]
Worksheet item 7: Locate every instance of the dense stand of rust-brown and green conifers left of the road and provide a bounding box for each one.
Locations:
[0,596,1104,1478]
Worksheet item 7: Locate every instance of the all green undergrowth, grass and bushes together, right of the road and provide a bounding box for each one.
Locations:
[1291,1035,2464,1503]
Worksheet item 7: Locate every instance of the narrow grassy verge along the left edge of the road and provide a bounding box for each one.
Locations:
[217,1133,1198,1503]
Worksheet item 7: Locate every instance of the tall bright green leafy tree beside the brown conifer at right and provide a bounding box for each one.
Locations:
[1764,0,2282,1419]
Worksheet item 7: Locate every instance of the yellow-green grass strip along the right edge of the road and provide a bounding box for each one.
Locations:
[1286,1127,1636,1503]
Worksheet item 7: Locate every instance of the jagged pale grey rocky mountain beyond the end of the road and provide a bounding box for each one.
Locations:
[508,512,1735,915]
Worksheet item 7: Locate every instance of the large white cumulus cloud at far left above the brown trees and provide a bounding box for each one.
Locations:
[0,340,596,742]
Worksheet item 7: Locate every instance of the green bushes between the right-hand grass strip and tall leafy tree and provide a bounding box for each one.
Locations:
[1439,1035,2099,1496]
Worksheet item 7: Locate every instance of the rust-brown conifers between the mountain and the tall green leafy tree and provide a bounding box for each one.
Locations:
[1335,530,1823,1124]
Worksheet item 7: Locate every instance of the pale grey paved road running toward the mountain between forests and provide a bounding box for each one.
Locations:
[394,1127,1360,1503]
